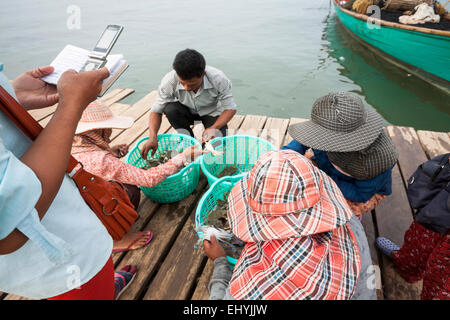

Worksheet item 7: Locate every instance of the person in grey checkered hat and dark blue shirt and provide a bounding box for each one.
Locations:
[282,92,398,215]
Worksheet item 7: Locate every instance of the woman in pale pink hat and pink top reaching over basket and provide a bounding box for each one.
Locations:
[72,100,201,252]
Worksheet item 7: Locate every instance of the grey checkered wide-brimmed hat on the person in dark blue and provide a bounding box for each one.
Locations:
[288,92,383,152]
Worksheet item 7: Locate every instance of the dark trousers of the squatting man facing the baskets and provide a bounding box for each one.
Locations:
[164,102,228,137]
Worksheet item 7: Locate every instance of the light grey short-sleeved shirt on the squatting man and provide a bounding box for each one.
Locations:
[151,66,236,117]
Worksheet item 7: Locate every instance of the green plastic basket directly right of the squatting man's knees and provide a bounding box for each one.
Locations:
[200,135,275,186]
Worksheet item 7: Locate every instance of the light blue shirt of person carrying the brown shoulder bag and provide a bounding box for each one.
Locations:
[0,66,112,299]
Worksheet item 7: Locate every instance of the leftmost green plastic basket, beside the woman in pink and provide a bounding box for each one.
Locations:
[125,133,200,203]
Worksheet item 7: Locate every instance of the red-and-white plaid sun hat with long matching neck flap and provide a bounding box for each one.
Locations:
[228,150,361,300]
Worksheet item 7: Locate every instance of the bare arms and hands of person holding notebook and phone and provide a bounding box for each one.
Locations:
[0,68,109,254]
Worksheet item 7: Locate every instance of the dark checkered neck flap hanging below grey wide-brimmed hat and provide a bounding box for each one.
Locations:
[327,131,398,180]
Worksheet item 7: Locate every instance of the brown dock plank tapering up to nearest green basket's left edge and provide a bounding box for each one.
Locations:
[143,210,206,300]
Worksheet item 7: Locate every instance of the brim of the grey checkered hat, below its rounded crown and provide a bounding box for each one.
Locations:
[288,110,384,152]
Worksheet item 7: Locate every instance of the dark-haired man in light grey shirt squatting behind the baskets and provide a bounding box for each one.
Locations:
[142,49,236,159]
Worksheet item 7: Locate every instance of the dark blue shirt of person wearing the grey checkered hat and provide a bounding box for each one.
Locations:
[282,140,392,202]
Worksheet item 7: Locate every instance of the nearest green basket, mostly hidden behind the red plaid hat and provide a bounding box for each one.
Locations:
[195,176,242,269]
